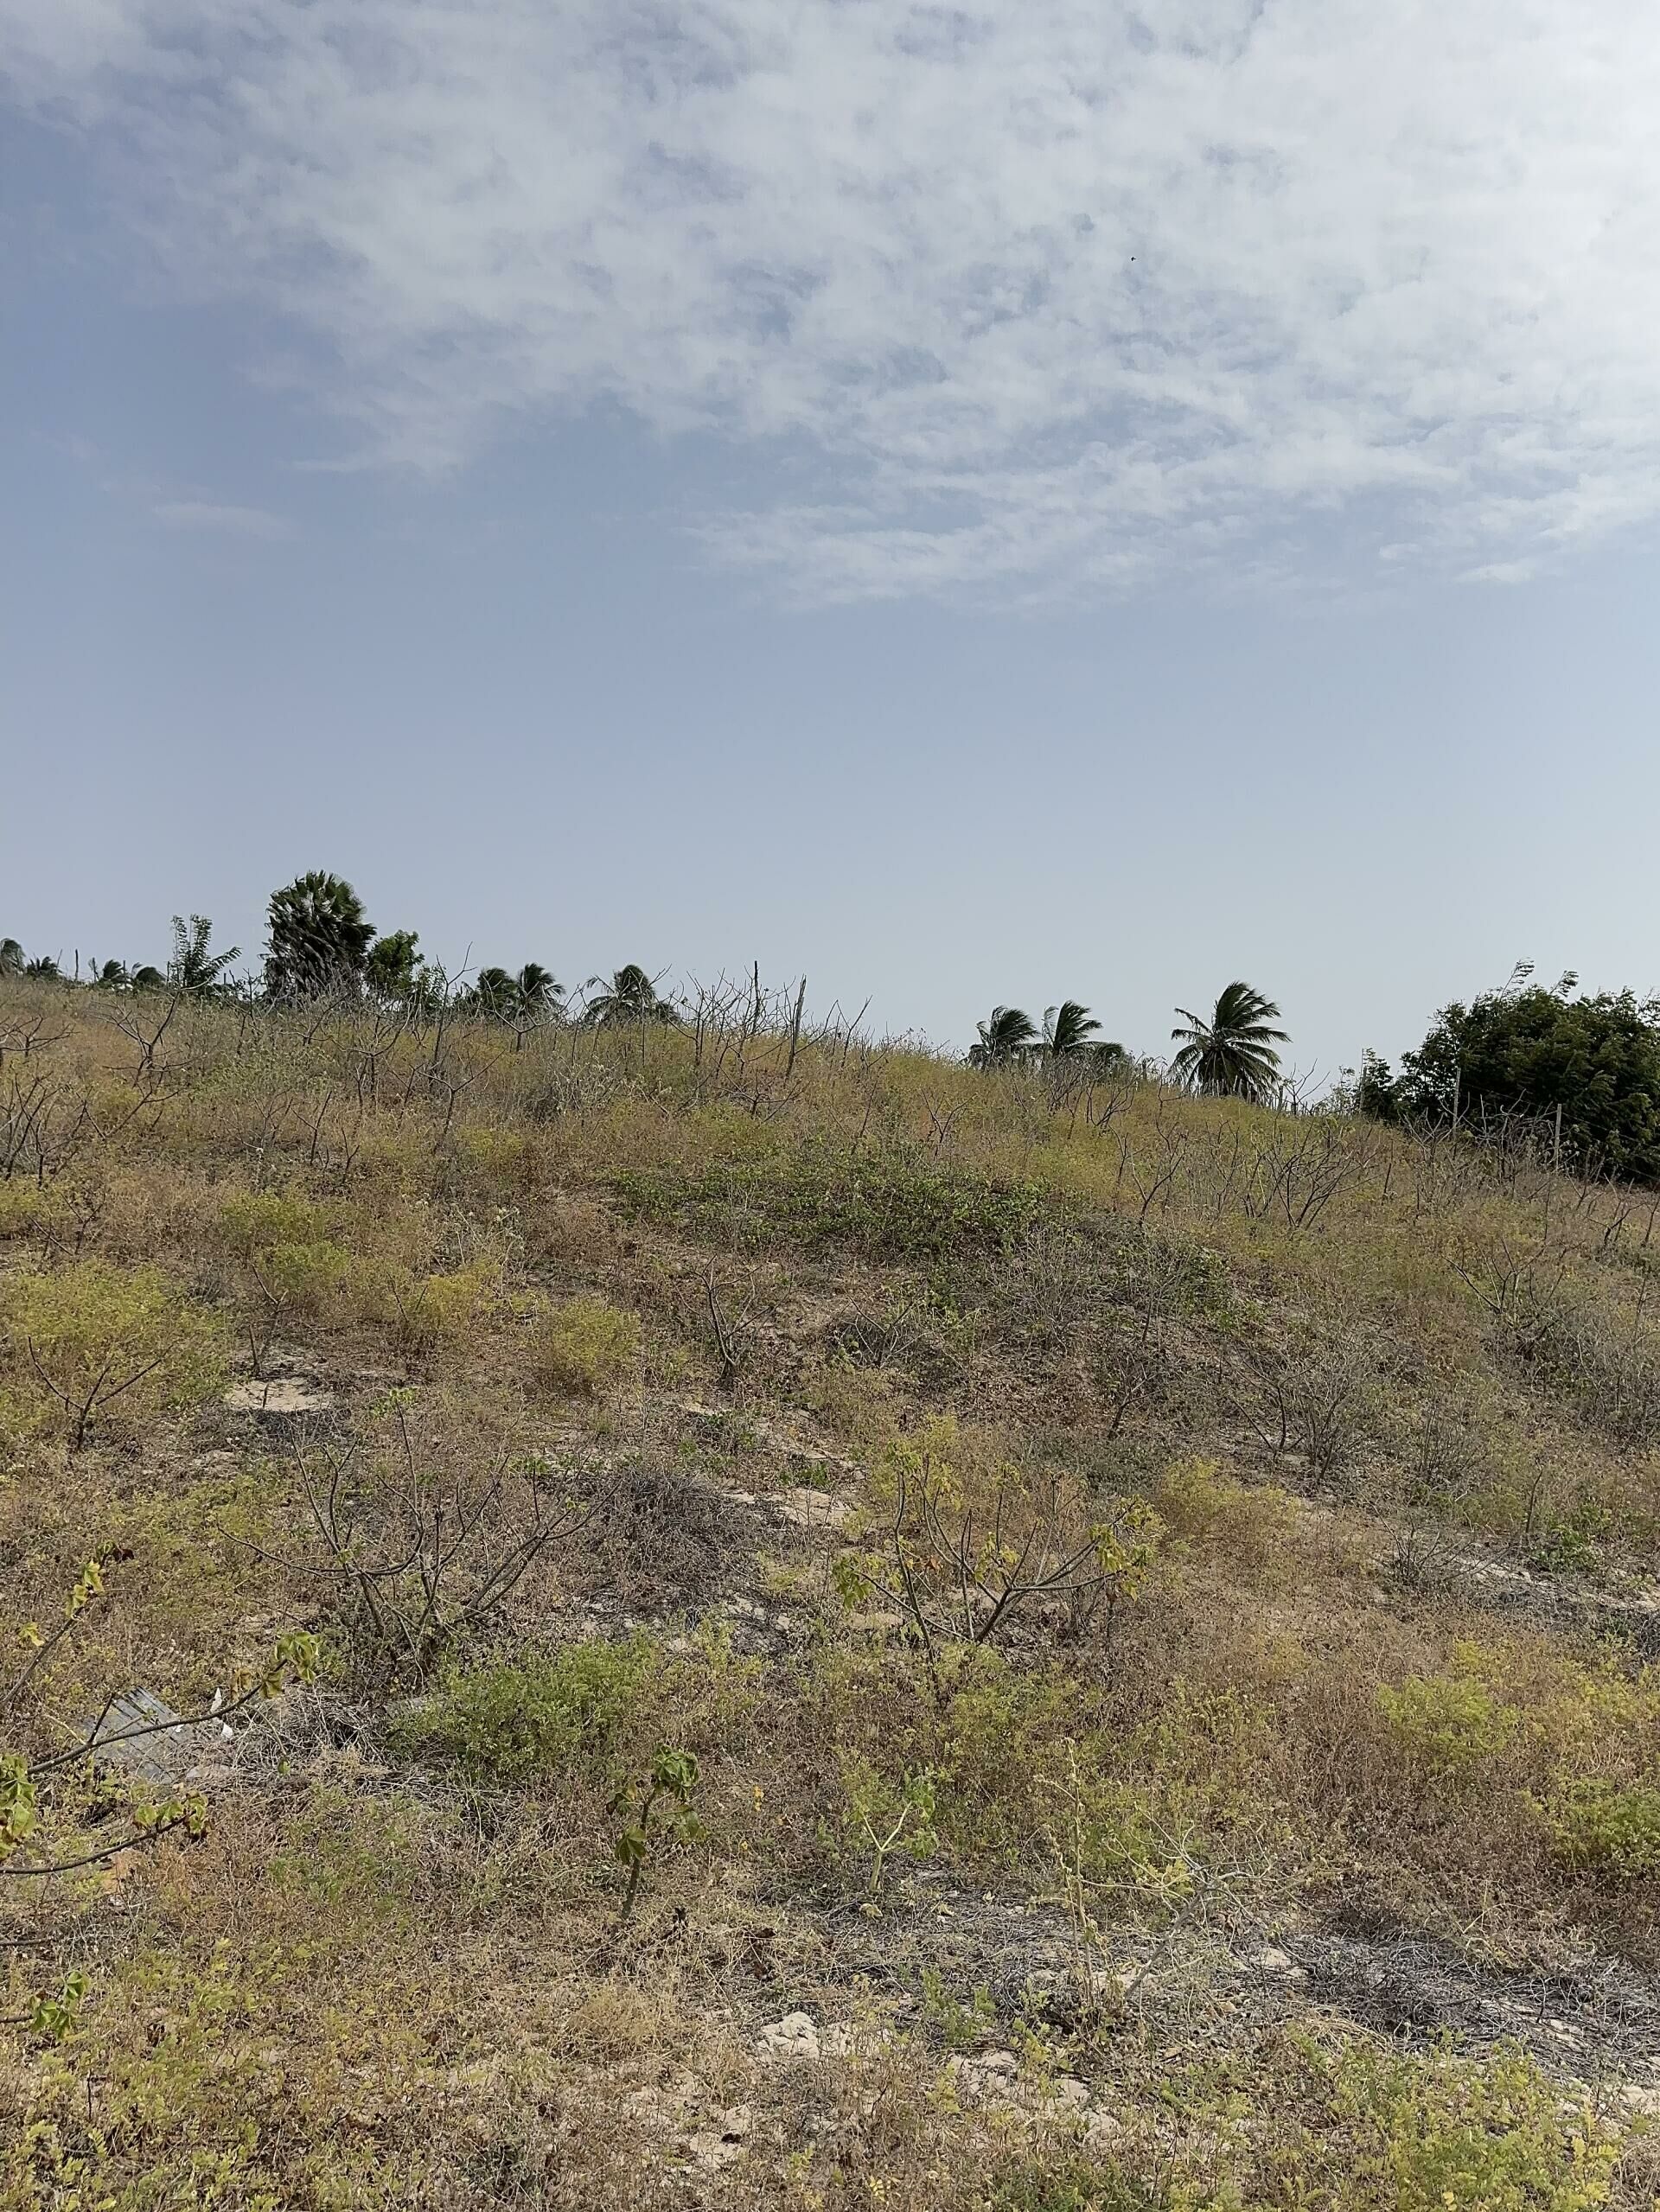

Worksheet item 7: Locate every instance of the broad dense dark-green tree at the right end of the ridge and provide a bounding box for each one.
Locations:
[1363,971,1660,1182]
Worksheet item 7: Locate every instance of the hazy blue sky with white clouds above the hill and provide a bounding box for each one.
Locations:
[0,0,1660,1081]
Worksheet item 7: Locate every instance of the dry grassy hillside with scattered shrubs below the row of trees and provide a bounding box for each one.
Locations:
[0,982,1660,2212]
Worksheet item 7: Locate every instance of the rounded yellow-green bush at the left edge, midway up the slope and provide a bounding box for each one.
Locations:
[0,1259,226,1447]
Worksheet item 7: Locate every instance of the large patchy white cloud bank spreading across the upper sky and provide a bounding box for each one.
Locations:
[13,0,1660,602]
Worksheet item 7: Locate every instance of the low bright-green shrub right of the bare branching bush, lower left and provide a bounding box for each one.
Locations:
[405,1637,664,1783]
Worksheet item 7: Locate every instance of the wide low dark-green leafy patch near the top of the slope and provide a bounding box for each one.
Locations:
[613,1141,1043,1259]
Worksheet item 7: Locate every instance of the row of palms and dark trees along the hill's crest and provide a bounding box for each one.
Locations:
[0,870,1660,1183]
